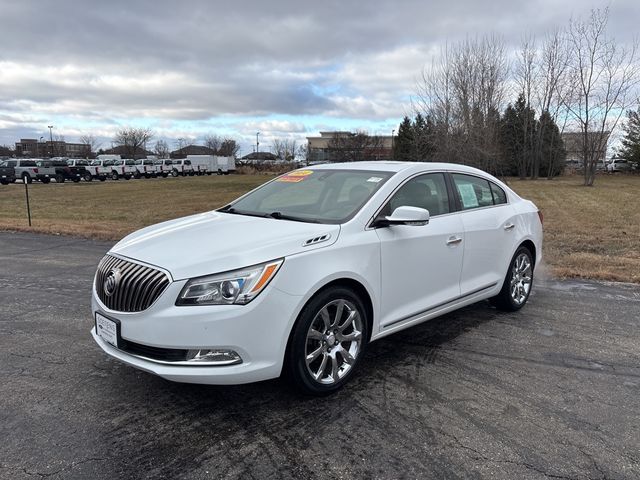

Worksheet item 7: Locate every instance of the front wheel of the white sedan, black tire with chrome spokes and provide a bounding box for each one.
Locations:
[284,286,369,396]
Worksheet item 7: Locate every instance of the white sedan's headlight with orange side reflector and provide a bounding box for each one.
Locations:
[176,258,284,305]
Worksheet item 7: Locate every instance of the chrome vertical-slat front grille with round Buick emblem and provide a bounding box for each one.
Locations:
[96,255,169,312]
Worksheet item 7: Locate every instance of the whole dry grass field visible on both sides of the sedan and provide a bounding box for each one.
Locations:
[0,175,640,283]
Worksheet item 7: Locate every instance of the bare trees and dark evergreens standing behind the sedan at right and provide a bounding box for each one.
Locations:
[408,8,640,185]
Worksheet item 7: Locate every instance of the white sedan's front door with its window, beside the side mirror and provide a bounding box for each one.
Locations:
[376,173,464,329]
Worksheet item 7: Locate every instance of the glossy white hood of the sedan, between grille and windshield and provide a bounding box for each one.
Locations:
[111,211,340,280]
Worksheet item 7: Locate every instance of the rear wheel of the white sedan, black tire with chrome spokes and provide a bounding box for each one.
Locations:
[489,246,534,312]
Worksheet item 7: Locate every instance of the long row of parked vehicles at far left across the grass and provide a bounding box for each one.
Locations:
[0,155,235,185]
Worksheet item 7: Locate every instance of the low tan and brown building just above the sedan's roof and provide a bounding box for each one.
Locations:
[307,131,394,163]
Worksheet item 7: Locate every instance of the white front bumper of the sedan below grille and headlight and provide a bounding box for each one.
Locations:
[91,280,302,385]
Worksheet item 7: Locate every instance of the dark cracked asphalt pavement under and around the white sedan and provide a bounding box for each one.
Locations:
[0,233,640,479]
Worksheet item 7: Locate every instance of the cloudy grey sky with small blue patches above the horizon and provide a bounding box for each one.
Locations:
[0,0,640,155]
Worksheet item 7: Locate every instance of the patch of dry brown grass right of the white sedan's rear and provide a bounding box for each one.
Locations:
[509,175,640,283]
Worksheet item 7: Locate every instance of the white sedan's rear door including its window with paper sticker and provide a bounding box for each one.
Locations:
[451,173,518,296]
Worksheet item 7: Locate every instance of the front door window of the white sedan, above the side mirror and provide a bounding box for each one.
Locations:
[381,173,450,217]
